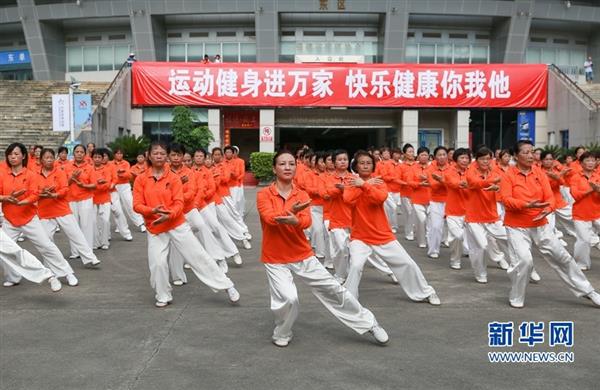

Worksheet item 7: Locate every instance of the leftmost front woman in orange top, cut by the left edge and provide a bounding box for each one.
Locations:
[0,143,79,291]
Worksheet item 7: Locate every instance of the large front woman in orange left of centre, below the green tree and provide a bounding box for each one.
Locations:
[133,142,240,307]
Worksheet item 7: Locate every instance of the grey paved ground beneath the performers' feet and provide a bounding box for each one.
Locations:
[0,190,600,390]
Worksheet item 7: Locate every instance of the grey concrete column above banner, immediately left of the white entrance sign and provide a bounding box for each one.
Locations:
[255,0,279,62]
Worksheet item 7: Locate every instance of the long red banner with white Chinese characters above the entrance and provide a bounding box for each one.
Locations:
[133,62,548,108]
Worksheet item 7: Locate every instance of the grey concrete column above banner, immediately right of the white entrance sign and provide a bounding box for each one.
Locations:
[379,0,408,63]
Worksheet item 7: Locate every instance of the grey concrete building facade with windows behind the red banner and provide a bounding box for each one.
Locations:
[0,0,600,155]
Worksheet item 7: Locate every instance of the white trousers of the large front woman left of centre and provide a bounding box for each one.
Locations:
[148,223,233,302]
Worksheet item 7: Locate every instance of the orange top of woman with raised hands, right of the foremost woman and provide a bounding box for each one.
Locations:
[343,179,396,245]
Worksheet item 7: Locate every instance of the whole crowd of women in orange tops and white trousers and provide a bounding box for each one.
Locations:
[0,141,600,347]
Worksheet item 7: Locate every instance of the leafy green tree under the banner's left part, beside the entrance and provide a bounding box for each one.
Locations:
[171,106,214,150]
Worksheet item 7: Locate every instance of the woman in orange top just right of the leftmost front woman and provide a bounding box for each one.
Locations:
[38,149,100,266]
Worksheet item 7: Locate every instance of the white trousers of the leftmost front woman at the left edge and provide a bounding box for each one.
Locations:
[2,216,73,283]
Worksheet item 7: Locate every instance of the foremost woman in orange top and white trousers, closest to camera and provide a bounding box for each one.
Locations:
[256,151,389,347]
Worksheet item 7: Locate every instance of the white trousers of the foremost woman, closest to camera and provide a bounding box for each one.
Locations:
[264,256,377,340]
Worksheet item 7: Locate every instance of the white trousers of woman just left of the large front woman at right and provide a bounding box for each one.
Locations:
[466,221,508,278]
